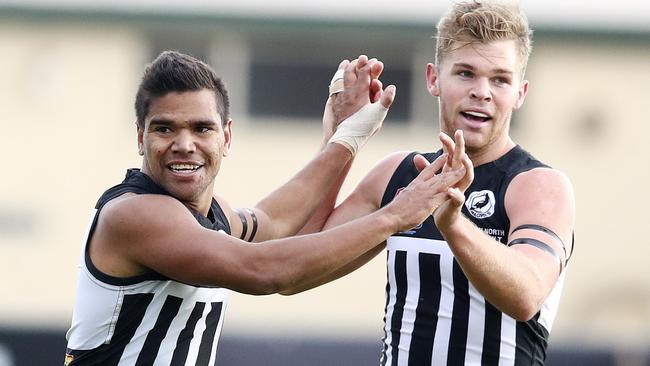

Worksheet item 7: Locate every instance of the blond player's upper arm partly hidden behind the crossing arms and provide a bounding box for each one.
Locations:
[323,151,409,230]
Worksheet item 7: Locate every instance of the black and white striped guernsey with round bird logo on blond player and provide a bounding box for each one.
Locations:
[381,146,566,366]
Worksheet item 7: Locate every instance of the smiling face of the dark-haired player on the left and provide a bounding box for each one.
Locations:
[138,89,232,213]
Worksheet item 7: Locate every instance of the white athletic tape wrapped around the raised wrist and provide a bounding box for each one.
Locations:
[329,102,388,155]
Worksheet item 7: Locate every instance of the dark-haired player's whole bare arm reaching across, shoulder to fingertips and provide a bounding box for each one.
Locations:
[90,154,465,294]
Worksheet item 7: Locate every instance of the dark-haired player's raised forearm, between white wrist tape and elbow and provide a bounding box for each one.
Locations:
[256,143,352,239]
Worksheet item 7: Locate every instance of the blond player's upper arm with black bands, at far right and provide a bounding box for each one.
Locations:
[505,168,575,282]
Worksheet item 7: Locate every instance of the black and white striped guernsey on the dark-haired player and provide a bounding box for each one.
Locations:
[65,169,230,366]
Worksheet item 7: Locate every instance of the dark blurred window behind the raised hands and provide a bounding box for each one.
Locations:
[248,39,412,122]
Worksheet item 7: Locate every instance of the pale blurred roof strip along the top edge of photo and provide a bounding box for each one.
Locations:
[0,0,650,33]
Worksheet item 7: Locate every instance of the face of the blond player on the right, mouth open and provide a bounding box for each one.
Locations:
[427,40,528,165]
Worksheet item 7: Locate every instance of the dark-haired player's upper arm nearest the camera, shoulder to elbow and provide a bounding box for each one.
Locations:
[92,195,270,292]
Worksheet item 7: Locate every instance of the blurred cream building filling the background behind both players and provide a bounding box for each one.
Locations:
[0,0,650,366]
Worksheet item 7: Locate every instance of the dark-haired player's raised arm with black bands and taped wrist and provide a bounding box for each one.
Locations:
[230,56,395,241]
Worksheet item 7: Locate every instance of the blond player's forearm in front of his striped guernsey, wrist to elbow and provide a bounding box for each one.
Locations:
[440,217,548,320]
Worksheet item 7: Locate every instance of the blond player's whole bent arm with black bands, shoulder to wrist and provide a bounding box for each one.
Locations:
[434,168,575,321]
